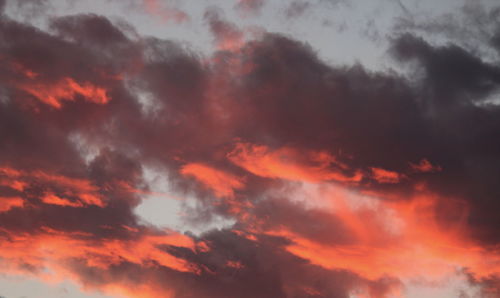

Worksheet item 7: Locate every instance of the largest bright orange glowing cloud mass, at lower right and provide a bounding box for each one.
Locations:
[266,188,500,280]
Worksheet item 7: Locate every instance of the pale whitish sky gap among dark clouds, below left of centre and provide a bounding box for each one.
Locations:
[134,167,235,235]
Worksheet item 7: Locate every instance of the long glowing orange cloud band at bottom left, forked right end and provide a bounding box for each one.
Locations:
[0,228,200,290]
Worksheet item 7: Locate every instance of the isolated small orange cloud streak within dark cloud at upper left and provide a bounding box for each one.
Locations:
[18,78,111,109]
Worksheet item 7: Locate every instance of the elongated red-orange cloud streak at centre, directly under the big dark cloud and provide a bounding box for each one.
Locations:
[227,143,362,182]
